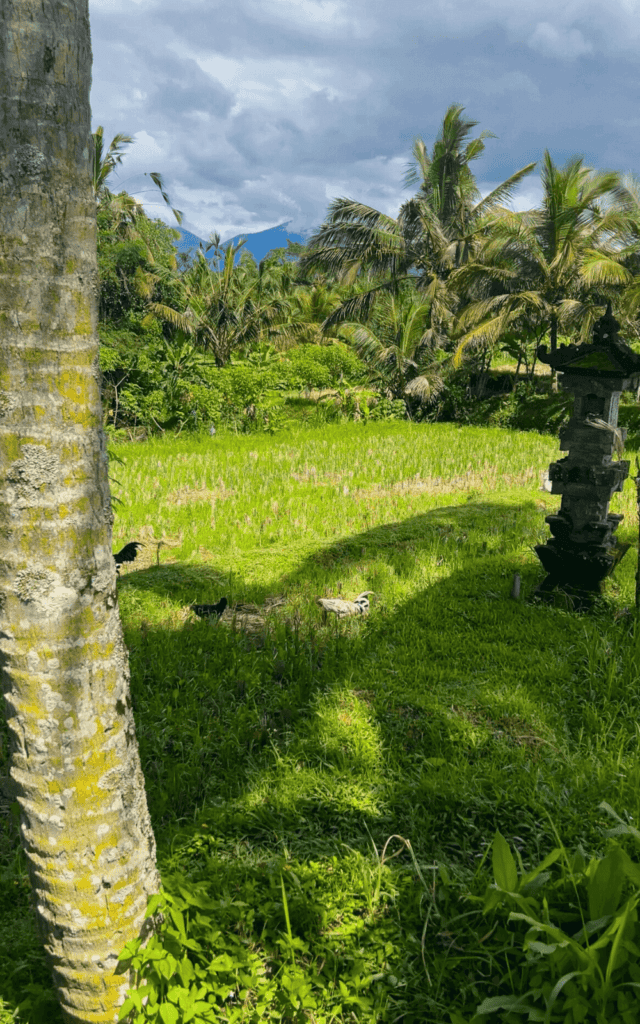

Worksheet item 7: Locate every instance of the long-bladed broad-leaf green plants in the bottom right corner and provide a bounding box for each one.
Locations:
[452,803,640,1024]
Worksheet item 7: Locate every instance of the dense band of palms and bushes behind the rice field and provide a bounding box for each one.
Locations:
[94,105,640,446]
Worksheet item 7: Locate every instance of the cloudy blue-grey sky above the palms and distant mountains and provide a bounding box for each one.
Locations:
[89,0,640,241]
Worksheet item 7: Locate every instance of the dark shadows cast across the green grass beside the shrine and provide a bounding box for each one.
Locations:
[113,489,634,865]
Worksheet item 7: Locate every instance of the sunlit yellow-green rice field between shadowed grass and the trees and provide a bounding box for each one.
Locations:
[113,423,636,589]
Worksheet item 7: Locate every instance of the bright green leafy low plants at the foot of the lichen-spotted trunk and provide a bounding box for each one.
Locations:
[117,857,394,1024]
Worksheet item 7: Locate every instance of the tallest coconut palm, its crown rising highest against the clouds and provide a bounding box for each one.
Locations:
[292,104,536,360]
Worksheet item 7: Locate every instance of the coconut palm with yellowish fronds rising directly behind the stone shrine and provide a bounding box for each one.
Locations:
[450,151,633,376]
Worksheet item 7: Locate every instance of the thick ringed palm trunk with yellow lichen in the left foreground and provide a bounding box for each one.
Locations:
[0,0,161,1024]
